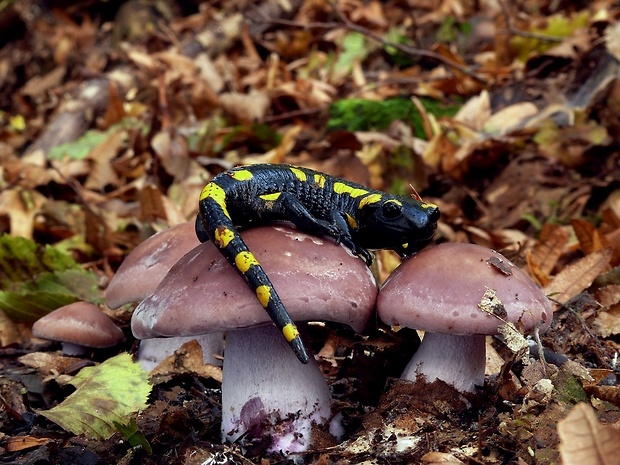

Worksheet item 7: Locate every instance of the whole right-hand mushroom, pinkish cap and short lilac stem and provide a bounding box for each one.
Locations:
[377,243,553,392]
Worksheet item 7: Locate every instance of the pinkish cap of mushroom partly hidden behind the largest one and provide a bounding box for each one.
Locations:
[106,221,200,308]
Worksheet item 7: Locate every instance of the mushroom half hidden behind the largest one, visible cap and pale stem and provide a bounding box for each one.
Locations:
[106,221,224,371]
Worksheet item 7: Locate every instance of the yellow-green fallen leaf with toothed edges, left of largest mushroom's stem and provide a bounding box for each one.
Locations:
[40,353,152,439]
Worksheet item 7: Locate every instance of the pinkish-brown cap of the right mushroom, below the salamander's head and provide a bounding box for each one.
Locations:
[377,243,553,335]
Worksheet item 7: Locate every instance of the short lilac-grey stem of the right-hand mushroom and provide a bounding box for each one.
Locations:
[401,332,486,392]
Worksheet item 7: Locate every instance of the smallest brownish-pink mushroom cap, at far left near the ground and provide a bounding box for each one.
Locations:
[32,302,125,348]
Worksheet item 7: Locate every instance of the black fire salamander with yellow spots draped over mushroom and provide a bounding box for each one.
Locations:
[196,164,439,363]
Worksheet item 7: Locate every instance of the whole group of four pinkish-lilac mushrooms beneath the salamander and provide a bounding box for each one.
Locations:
[46,214,553,454]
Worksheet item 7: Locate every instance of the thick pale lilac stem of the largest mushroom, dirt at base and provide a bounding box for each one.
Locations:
[222,325,331,453]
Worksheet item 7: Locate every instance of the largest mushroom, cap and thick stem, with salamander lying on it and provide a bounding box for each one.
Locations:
[132,226,377,453]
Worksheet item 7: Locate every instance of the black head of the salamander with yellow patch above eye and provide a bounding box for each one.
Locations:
[355,195,439,257]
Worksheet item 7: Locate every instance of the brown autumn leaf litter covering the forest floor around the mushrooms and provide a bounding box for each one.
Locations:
[0,0,620,465]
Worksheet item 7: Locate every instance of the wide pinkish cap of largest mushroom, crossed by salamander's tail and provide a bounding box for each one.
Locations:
[131,226,377,339]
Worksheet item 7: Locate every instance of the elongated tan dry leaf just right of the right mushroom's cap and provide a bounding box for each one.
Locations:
[543,249,612,302]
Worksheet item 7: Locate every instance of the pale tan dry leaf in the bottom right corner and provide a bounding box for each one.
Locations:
[558,402,620,465]
